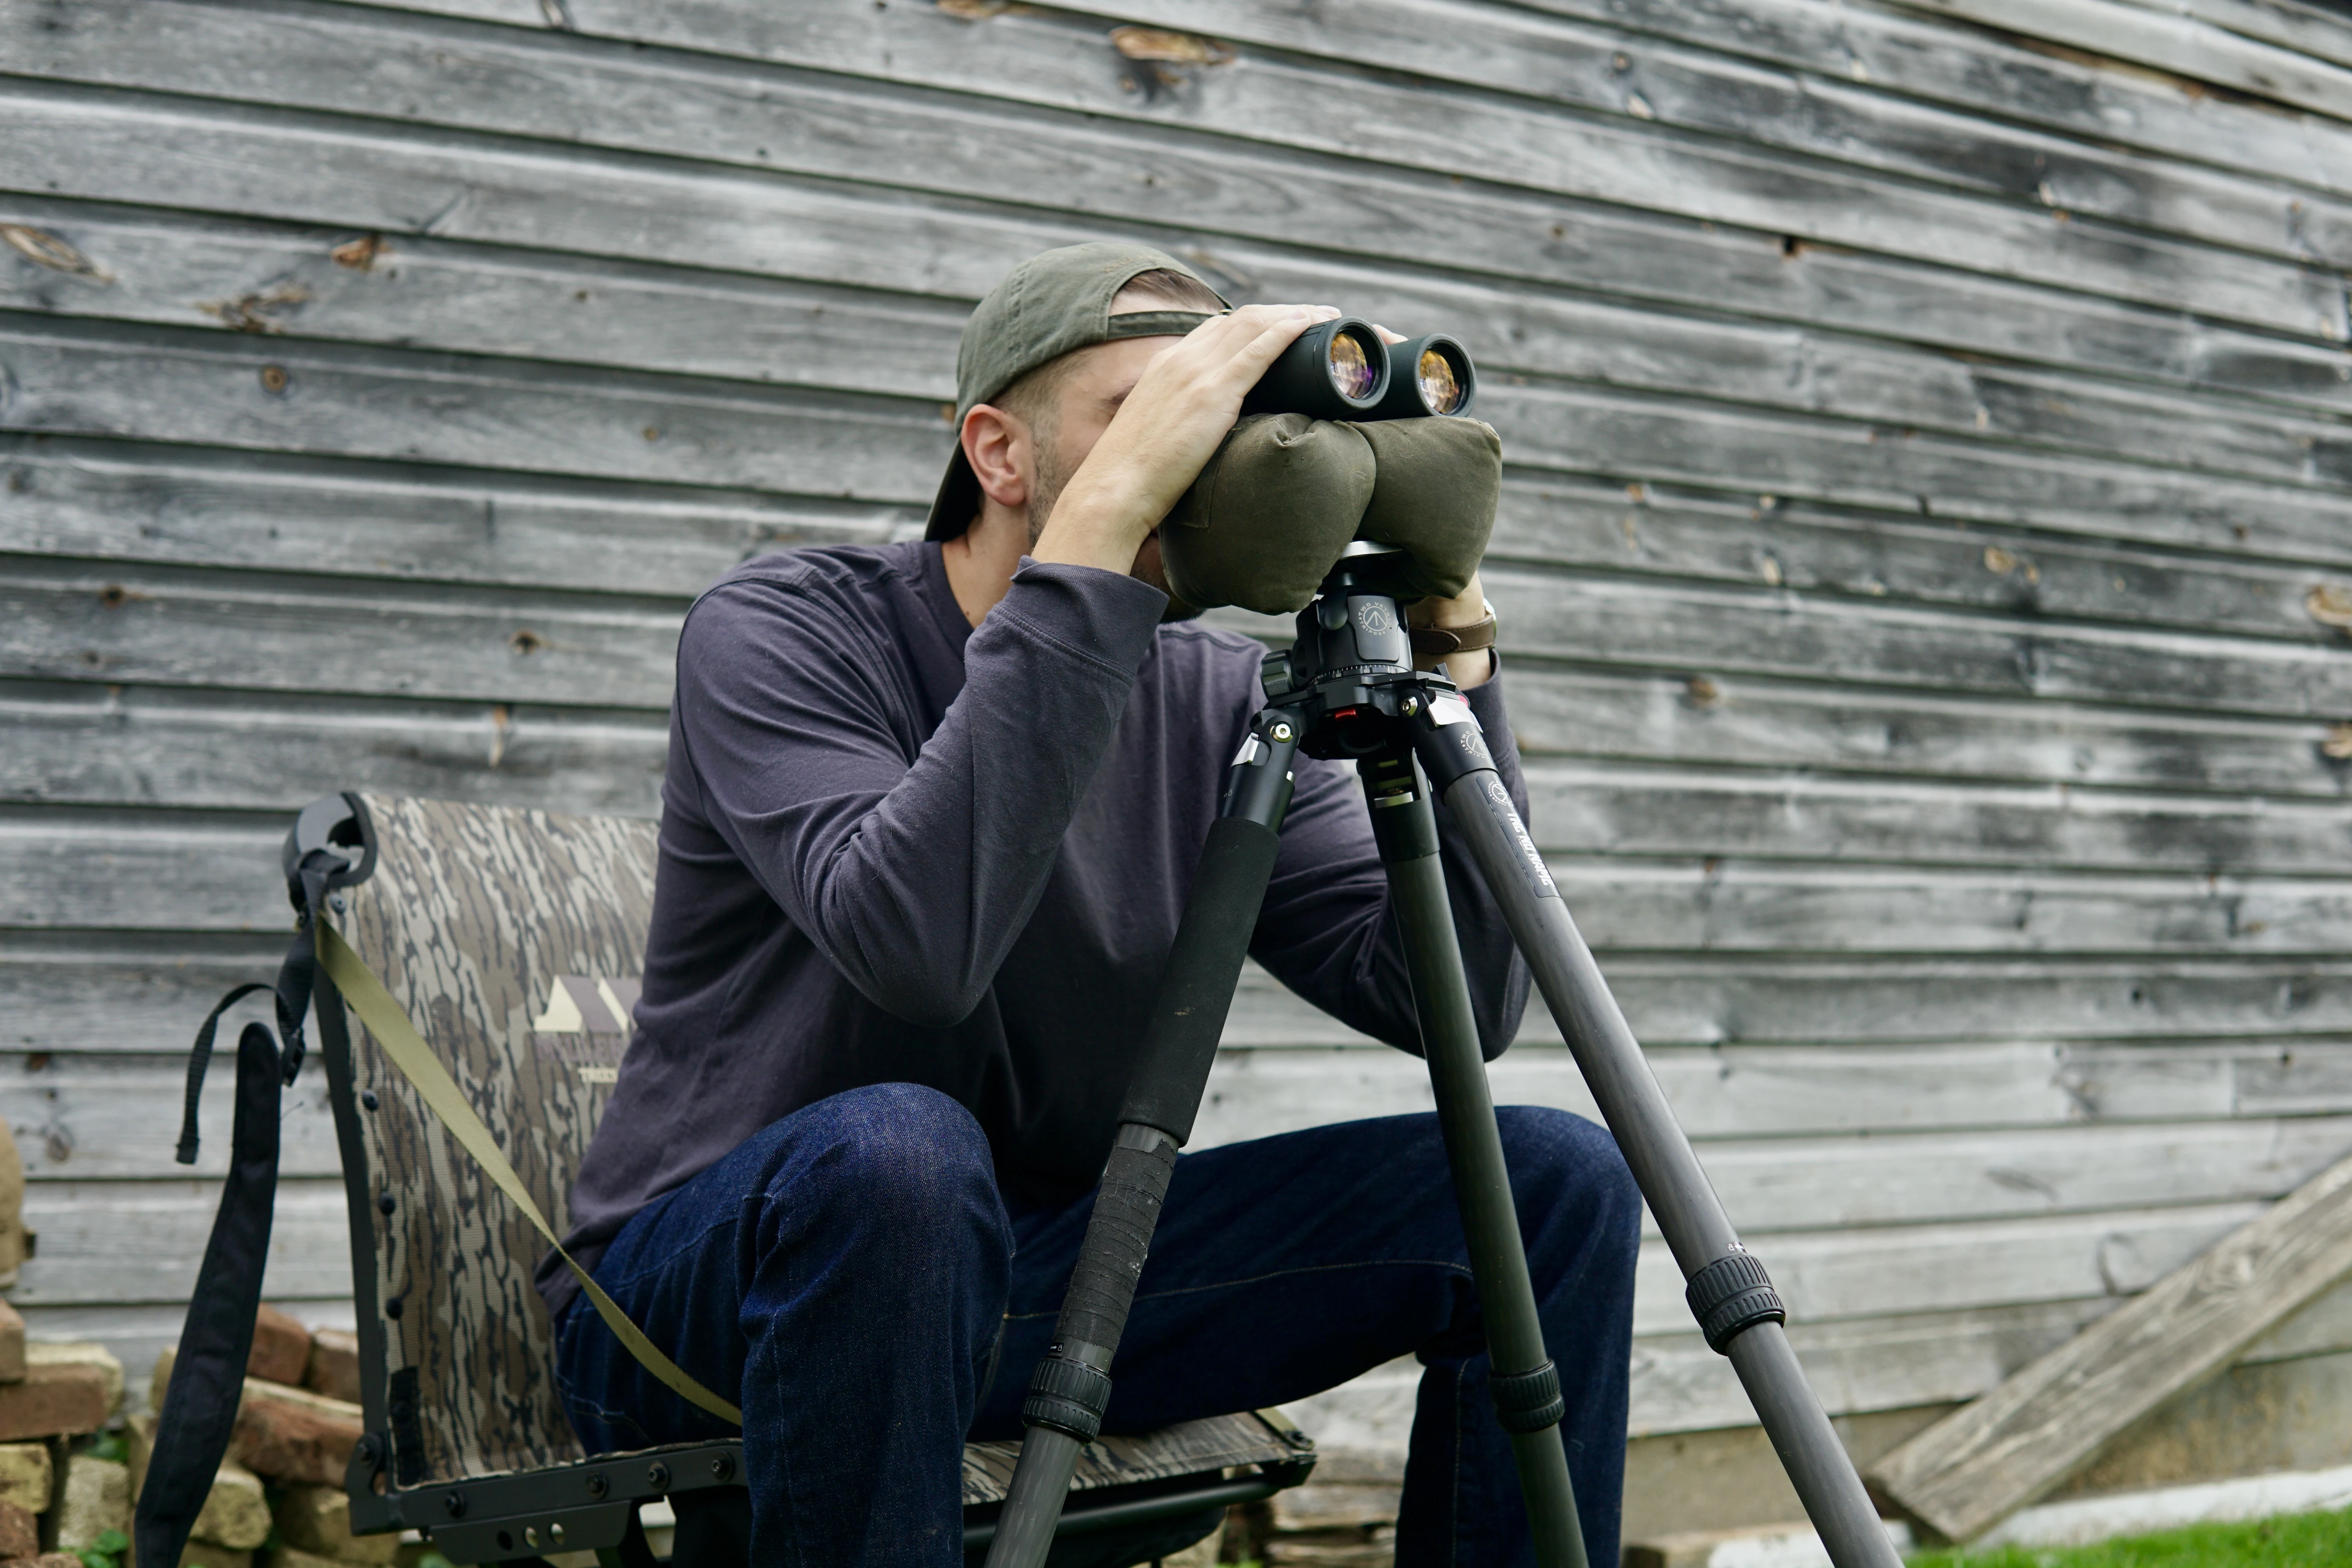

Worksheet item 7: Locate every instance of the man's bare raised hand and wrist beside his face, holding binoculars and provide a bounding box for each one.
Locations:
[1030,306,1338,573]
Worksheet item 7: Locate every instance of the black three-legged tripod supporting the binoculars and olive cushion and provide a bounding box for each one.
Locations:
[988,541,1898,1568]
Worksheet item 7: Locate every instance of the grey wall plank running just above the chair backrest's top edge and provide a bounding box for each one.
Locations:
[14,653,2352,825]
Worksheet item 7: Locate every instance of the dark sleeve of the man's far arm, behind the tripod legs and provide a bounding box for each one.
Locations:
[1249,672,1526,1060]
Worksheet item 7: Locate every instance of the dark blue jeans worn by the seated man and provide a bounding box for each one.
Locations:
[557,1084,1642,1568]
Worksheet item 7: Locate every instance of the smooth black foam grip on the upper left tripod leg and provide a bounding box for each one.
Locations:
[1120,816,1282,1145]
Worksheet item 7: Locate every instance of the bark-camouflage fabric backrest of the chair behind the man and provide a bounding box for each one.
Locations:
[341,795,654,1488]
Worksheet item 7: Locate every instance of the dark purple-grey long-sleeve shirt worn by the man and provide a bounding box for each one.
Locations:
[539,543,1526,1307]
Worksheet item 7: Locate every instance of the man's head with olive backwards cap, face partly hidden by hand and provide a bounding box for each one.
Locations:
[924,245,1225,566]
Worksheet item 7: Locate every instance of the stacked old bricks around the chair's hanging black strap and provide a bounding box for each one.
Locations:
[133,1307,400,1568]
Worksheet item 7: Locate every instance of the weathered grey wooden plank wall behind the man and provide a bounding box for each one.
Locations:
[0,0,2352,1523]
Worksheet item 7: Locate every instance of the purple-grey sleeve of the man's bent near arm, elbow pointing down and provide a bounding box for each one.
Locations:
[677,562,1167,1027]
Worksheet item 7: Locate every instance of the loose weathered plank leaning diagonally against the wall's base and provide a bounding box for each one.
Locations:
[1870,1159,2352,1540]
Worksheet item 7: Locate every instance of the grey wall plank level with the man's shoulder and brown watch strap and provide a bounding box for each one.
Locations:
[14,545,2352,729]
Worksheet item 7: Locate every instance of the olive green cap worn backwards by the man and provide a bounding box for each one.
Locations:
[922,242,1230,541]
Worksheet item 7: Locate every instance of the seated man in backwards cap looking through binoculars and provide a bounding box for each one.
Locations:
[541,245,1639,1568]
